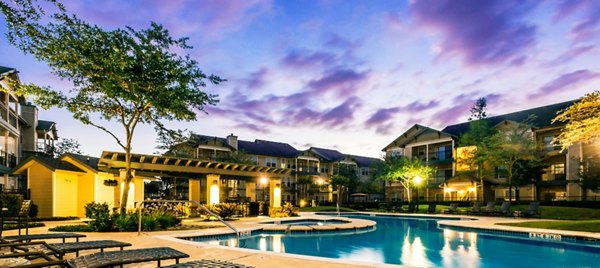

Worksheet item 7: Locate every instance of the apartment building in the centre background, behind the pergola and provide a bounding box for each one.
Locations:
[167,134,378,204]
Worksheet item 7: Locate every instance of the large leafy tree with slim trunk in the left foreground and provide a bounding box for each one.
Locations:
[2,0,224,212]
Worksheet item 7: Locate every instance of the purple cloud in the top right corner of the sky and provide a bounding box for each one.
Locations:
[554,0,600,42]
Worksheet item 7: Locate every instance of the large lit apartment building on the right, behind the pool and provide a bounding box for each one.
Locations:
[383,101,600,200]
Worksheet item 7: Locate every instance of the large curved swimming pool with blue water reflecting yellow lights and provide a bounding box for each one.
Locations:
[183,215,600,267]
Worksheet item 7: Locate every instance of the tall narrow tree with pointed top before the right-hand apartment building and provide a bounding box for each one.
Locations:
[459,98,498,201]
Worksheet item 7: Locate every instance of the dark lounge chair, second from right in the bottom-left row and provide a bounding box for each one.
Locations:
[66,247,190,268]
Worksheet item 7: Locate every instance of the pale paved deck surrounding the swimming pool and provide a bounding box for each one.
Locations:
[3,213,600,268]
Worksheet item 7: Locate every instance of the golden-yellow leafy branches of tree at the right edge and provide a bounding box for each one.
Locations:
[552,90,600,150]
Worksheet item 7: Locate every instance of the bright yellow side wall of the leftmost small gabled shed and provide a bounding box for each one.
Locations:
[54,170,81,217]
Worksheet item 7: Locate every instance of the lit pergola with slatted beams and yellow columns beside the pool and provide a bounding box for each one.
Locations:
[98,151,291,207]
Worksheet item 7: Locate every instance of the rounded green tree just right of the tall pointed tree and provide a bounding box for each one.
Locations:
[487,117,541,200]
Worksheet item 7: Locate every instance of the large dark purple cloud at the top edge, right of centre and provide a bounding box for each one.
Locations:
[409,0,536,66]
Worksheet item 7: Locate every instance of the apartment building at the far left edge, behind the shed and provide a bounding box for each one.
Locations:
[0,66,58,191]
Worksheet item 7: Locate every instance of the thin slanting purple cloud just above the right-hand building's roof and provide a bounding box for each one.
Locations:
[528,70,600,99]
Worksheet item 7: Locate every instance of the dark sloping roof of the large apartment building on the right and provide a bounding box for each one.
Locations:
[442,100,575,137]
